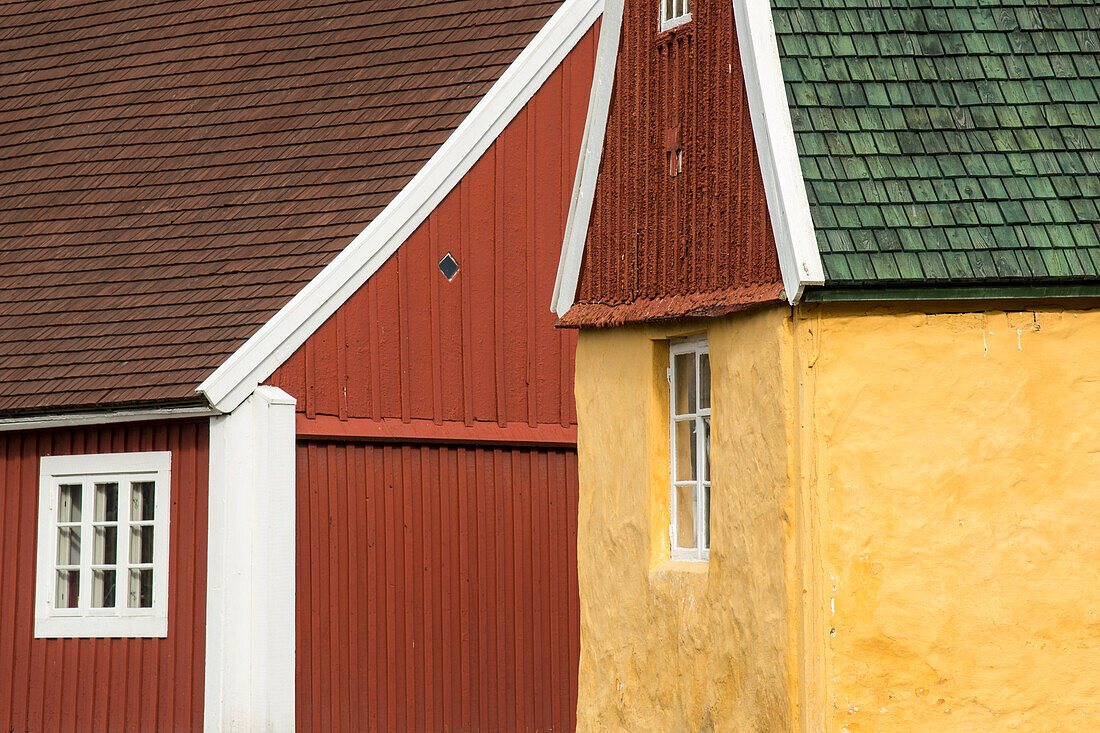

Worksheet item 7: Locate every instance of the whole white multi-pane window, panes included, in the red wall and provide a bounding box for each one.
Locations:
[34,451,172,637]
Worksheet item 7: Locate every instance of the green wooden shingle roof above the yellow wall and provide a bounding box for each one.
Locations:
[772,0,1100,286]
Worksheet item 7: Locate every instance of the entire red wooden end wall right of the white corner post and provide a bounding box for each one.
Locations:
[262,22,598,732]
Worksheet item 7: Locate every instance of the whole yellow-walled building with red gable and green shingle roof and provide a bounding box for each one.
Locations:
[553,0,1100,733]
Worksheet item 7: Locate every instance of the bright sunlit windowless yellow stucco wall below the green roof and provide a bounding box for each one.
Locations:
[800,306,1100,733]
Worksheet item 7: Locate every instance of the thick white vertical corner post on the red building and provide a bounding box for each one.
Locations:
[205,386,296,733]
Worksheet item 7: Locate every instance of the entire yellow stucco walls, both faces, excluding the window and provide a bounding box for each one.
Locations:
[576,299,1100,733]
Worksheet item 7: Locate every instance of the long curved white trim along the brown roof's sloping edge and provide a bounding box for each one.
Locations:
[198,0,601,412]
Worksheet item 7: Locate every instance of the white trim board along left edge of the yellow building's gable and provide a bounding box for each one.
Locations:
[550,0,623,316]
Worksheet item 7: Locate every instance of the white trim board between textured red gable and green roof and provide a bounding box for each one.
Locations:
[733,0,825,304]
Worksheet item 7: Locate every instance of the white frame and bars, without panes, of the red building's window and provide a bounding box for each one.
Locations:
[34,451,172,638]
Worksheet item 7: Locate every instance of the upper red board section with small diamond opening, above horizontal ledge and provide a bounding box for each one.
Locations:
[262,22,598,426]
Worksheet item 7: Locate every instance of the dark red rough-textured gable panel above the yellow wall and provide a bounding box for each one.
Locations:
[562,0,782,326]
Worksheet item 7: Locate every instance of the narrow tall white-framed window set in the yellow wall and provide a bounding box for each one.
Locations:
[669,337,711,560]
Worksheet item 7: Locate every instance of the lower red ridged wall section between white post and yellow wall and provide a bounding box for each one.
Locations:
[297,441,580,732]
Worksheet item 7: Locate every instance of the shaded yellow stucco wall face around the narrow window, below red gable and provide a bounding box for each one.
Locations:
[576,308,795,731]
